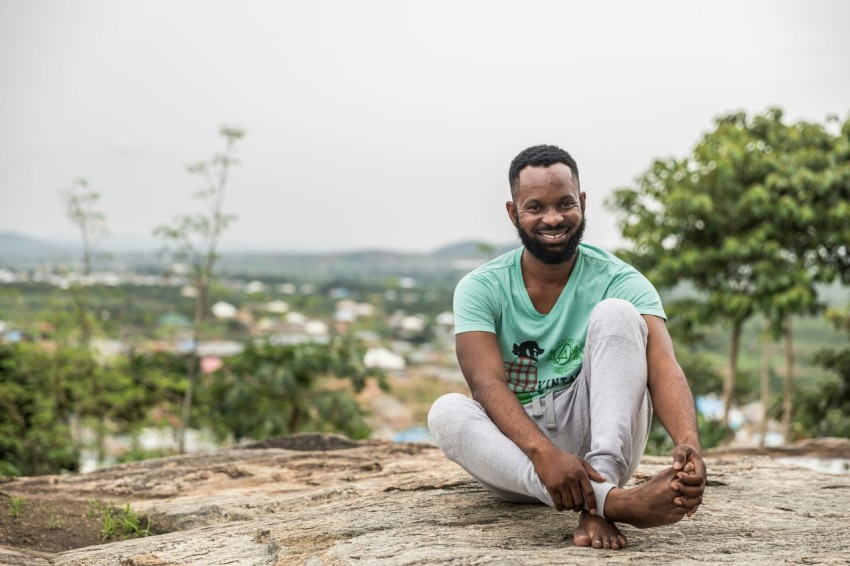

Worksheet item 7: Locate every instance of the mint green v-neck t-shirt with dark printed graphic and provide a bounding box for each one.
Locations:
[454,244,667,403]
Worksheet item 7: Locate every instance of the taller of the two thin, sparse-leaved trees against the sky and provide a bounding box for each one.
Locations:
[154,126,245,453]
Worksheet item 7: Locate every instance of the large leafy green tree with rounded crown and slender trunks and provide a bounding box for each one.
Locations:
[608,109,850,432]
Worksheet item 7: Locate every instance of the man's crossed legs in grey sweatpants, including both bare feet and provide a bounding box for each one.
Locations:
[428,299,681,548]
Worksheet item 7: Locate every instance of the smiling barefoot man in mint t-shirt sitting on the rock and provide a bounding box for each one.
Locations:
[428,145,706,549]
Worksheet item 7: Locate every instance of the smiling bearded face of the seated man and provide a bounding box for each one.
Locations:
[507,163,585,265]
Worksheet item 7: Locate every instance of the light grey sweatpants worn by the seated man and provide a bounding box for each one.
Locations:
[428,299,652,517]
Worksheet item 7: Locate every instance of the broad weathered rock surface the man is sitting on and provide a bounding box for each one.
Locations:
[0,437,850,566]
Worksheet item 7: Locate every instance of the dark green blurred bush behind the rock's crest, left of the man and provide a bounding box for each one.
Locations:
[198,338,383,441]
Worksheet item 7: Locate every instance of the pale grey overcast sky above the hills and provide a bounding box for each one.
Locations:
[0,0,850,251]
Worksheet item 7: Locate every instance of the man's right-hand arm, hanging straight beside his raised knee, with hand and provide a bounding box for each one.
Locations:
[643,315,707,516]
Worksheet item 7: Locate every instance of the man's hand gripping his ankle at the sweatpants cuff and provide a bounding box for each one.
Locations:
[534,446,605,514]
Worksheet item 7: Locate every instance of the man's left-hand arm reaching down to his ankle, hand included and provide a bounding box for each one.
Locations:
[456,332,605,513]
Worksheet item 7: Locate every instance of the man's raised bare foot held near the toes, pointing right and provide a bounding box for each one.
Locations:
[605,468,688,529]
